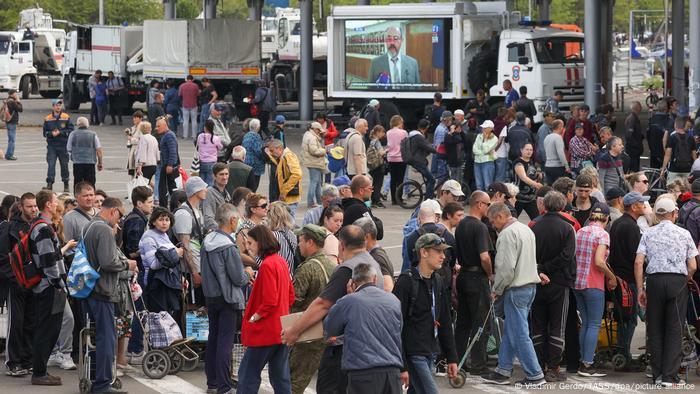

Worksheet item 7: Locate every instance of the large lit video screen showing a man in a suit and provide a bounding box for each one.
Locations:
[345,19,450,92]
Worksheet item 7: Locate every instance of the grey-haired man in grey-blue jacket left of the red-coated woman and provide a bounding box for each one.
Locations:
[200,203,254,393]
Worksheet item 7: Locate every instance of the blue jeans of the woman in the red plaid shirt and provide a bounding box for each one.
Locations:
[574,289,605,364]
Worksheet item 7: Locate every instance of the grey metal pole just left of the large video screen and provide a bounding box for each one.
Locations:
[299,0,314,120]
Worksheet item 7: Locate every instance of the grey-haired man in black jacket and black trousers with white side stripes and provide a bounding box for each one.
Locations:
[530,191,578,382]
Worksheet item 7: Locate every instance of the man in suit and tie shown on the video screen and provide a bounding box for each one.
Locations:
[367,26,420,86]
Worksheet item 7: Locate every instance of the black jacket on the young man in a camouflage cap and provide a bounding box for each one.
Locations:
[394,268,457,370]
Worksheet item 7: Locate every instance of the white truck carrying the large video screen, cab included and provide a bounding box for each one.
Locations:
[328,1,583,122]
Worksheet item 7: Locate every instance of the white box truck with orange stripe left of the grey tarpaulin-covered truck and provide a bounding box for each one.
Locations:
[62,26,146,110]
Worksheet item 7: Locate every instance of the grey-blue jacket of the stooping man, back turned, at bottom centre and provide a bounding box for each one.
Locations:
[323,284,403,371]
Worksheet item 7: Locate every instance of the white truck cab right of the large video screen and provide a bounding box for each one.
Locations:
[489,27,584,123]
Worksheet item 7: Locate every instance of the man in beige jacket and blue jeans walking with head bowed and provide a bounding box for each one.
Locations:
[481,203,549,388]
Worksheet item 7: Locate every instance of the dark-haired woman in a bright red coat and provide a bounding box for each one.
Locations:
[236,226,294,394]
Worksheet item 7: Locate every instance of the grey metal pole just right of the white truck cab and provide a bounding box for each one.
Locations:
[583,0,601,111]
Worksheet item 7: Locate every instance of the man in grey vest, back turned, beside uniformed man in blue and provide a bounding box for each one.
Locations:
[66,116,102,187]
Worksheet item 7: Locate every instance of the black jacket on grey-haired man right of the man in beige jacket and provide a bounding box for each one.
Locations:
[532,212,576,287]
